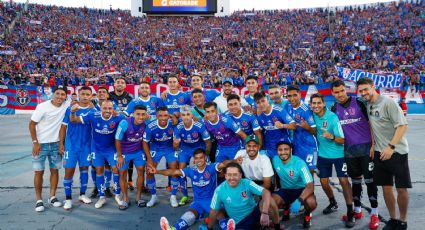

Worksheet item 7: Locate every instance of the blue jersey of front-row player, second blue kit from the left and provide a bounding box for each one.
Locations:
[80,112,125,153]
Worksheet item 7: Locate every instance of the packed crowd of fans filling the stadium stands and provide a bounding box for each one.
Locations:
[0,0,425,87]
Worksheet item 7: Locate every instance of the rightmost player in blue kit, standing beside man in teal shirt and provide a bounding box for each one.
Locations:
[284,85,317,174]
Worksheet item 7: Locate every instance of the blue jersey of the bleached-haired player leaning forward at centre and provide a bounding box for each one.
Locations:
[174,120,211,150]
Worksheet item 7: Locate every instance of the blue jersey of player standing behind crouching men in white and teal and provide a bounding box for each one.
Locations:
[257,105,295,150]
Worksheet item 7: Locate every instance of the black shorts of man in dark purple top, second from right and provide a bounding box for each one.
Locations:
[345,156,374,179]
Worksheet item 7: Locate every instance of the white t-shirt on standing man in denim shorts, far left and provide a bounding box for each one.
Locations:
[31,100,70,144]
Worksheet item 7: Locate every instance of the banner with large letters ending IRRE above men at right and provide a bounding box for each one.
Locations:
[335,66,403,89]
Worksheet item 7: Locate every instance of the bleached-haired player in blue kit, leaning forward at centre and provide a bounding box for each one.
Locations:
[173,105,211,205]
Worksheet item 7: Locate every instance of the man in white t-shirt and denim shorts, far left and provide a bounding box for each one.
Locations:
[29,87,69,212]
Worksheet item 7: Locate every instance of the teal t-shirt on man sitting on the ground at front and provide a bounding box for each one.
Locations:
[210,178,264,224]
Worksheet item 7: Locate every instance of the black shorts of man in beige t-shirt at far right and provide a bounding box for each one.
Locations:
[373,152,412,188]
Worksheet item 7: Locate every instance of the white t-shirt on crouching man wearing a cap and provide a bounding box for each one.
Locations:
[235,149,274,181]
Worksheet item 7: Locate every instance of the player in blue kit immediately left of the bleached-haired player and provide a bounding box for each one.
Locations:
[143,106,179,208]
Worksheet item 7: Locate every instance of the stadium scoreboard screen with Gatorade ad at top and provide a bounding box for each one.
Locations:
[143,0,217,14]
